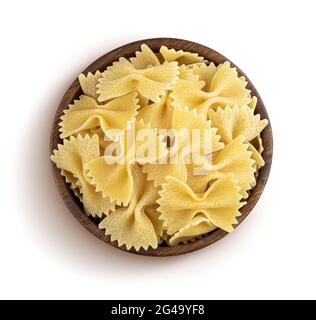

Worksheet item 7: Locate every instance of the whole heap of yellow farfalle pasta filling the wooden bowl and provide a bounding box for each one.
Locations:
[51,44,268,251]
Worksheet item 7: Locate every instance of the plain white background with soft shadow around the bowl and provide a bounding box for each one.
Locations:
[0,0,316,299]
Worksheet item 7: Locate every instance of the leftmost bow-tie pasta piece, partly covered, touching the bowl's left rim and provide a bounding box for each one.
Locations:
[51,135,115,217]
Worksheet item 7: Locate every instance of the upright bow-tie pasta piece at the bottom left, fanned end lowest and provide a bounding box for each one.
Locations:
[99,166,162,251]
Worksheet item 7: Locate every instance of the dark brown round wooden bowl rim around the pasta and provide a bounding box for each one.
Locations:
[50,38,273,257]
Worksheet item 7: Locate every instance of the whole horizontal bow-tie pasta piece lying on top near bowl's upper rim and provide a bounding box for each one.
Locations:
[97,58,179,102]
